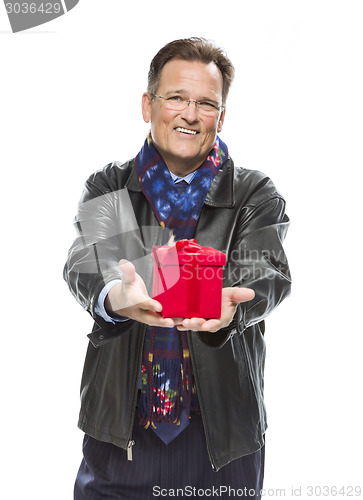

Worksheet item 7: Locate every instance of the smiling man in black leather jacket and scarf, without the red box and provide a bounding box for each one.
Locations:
[64,38,290,500]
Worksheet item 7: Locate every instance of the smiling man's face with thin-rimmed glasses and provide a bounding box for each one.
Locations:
[142,59,225,176]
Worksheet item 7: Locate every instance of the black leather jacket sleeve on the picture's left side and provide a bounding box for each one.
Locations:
[63,166,143,345]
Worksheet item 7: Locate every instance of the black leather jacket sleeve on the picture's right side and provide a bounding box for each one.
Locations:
[199,177,291,348]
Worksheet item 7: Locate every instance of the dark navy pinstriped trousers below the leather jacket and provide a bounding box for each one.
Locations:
[74,416,264,500]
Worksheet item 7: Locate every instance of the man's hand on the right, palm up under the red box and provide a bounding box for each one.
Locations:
[177,287,255,333]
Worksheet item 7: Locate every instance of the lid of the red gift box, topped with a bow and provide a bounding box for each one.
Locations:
[152,238,226,266]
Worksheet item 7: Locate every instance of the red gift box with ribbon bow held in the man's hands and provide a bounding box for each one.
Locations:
[152,239,226,318]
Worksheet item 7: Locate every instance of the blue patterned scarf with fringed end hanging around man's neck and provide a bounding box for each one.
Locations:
[135,134,228,434]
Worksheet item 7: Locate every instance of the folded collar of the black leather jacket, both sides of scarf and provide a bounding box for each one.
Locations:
[125,158,234,208]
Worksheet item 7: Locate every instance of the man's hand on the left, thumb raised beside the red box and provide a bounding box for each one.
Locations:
[105,260,180,328]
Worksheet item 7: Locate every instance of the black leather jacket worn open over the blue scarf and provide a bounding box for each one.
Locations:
[64,158,290,470]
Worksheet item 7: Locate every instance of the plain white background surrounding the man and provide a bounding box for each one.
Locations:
[0,0,363,500]
